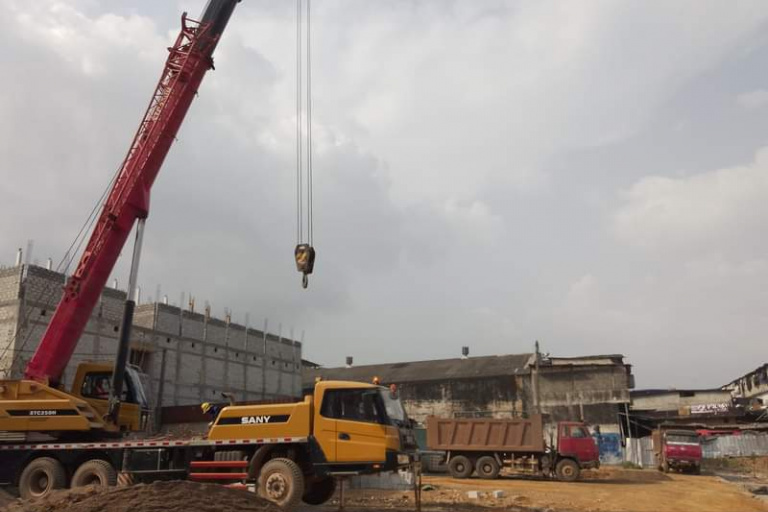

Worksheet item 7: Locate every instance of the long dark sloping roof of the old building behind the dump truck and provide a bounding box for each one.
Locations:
[302,354,533,383]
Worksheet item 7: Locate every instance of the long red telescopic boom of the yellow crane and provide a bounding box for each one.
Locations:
[25,0,239,384]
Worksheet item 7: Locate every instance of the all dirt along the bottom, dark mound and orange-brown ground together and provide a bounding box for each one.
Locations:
[0,468,768,512]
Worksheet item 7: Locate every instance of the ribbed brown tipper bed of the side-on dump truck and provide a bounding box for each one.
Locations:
[427,415,545,453]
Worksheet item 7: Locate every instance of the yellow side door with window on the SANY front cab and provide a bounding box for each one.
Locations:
[323,388,387,464]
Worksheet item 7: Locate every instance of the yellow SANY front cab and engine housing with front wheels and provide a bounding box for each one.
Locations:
[206,381,416,508]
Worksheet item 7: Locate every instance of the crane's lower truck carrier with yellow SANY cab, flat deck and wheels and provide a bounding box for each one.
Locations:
[0,381,416,509]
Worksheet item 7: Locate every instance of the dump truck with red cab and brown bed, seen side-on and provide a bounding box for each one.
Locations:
[427,414,600,482]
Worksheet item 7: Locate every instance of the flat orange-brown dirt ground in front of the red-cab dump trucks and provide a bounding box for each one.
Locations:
[312,468,768,512]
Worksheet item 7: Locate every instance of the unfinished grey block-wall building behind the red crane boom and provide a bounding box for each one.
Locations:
[0,265,301,406]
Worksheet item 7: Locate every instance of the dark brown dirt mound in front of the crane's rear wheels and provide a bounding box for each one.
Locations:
[0,481,281,512]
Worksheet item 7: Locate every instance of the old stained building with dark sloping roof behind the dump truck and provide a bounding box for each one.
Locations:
[304,353,633,432]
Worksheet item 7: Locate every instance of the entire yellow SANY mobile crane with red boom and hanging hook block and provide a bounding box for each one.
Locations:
[0,0,415,508]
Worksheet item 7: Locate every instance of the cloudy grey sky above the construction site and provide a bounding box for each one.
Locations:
[0,0,768,388]
